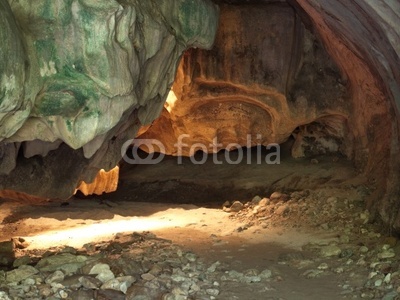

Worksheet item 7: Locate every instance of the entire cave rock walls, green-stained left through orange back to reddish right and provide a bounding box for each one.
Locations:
[0,0,400,230]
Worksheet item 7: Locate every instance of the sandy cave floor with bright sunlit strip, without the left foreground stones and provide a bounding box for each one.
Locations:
[0,151,400,299]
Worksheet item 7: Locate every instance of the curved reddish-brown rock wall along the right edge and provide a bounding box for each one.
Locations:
[297,0,400,231]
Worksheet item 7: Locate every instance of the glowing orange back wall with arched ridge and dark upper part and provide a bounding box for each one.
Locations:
[140,3,353,158]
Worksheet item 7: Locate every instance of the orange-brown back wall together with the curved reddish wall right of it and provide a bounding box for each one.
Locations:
[141,0,400,230]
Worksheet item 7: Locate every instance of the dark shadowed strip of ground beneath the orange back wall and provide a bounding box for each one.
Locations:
[96,136,354,208]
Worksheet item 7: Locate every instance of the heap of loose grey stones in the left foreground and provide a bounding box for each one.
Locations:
[0,232,272,300]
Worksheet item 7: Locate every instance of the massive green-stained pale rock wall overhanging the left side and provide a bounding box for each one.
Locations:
[0,0,218,198]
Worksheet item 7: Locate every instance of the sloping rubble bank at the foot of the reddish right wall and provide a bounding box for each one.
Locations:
[223,187,400,300]
